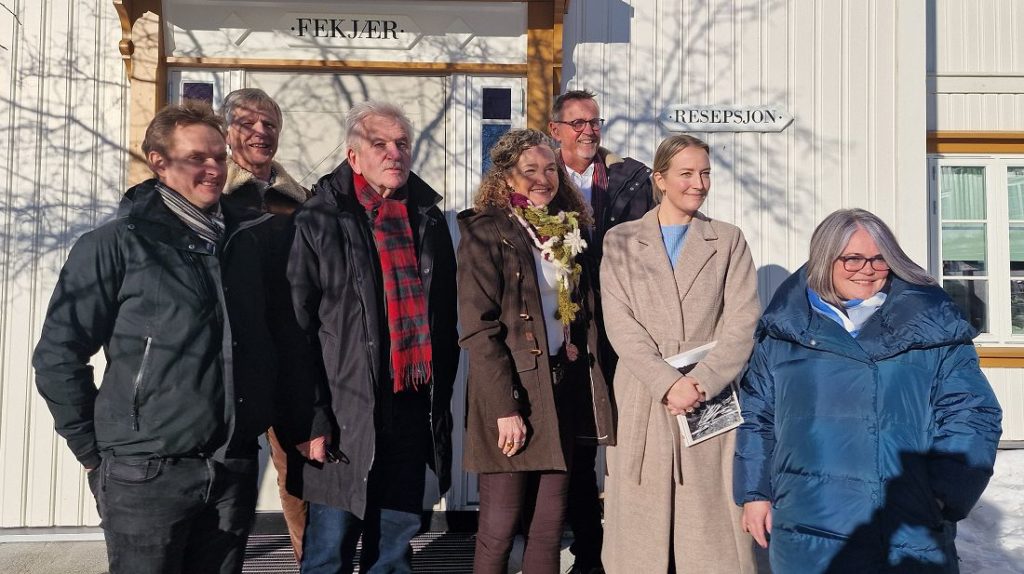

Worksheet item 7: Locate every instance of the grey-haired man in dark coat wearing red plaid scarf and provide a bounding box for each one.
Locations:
[288,101,459,573]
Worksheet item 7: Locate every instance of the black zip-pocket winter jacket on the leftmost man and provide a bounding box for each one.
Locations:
[33,180,287,468]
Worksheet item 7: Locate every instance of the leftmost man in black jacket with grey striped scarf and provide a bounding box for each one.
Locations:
[33,105,288,573]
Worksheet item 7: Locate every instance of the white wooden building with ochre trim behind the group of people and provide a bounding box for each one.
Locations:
[0,0,1024,528]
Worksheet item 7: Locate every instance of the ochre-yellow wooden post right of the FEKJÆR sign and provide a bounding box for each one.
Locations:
[526,2,555,131]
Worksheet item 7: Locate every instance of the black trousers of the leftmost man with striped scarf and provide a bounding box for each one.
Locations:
[89,456,259,574]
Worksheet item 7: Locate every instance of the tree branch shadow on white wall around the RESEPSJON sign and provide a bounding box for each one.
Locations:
[562,0,841,233]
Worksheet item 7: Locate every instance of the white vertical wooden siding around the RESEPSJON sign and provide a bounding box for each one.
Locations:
[563,0,928,302]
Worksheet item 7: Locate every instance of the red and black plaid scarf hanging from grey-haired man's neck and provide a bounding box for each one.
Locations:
[352,174,431,393]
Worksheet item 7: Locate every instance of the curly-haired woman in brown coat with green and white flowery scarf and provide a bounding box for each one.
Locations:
[458,130,613,574]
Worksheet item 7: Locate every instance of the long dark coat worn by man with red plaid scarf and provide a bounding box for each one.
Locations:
[280,163,459,517]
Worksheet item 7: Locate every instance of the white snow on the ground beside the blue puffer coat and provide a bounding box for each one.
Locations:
[956,449,1024,574]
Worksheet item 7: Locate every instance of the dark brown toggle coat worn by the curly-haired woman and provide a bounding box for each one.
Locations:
[458,209,614,473]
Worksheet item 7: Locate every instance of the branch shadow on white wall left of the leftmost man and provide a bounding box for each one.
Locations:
[0,5,129,290]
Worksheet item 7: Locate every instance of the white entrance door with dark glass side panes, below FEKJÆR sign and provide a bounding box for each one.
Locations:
[168,70,526,511]
